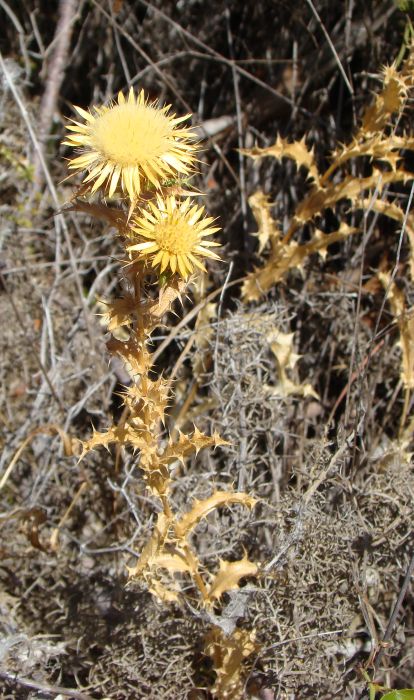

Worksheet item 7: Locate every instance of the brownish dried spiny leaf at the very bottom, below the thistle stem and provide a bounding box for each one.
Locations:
[205,627,258,700]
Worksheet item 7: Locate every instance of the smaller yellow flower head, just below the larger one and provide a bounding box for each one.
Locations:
[128,196,220,279]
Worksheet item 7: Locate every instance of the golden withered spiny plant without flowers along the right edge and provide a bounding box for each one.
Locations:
[243,44,414,434]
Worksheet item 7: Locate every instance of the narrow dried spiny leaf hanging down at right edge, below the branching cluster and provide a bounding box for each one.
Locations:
[378,272,414,390]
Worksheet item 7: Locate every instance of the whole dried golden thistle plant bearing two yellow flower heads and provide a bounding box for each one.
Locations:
[63,89,258,698]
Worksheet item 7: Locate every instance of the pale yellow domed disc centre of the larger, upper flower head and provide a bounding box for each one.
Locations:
[92,103,172,167]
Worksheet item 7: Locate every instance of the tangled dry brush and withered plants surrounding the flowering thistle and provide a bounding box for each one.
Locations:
[0,0,414,700]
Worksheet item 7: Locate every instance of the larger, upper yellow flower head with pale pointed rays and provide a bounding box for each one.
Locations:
[63,88,197,202]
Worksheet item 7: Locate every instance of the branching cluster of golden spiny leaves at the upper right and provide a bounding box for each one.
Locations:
[243,51,414,301]
